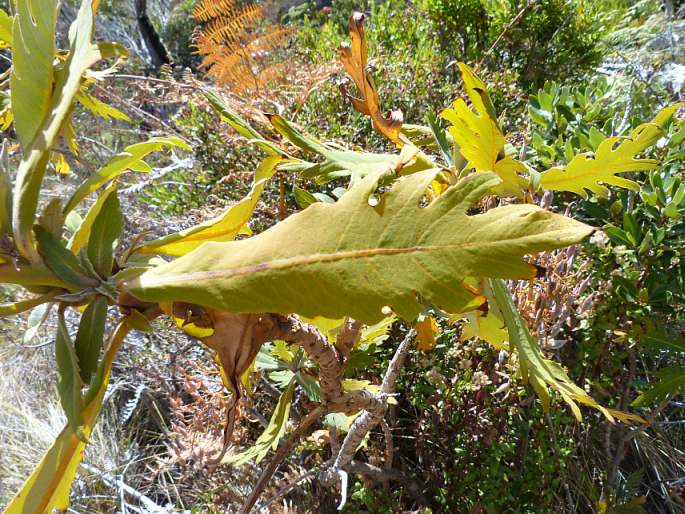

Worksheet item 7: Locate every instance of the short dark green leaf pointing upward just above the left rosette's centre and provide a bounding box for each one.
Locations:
[88,187,124,279]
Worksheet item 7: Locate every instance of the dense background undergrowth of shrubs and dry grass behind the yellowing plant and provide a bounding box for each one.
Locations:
[0,0,685,514]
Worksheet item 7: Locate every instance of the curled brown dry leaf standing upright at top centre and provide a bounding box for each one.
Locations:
[340,12,408,146]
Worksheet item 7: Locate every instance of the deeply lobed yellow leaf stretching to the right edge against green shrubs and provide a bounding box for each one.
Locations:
[540,102,685,198]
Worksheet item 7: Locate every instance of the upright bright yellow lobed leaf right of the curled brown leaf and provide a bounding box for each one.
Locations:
[440,63,527,195]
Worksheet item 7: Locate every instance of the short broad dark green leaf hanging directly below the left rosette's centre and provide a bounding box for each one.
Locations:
[75,296,107,384]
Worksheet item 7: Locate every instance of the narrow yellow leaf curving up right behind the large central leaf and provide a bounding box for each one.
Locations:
[137,155,281,256]
